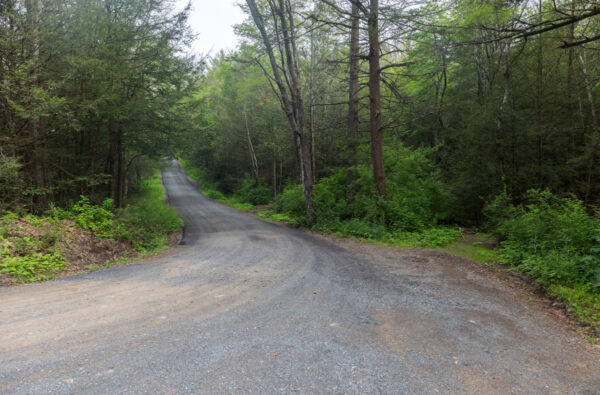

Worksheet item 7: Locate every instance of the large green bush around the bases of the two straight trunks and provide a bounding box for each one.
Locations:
[304,145,451,233]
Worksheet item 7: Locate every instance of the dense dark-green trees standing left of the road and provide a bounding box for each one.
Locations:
[0,0,197,213]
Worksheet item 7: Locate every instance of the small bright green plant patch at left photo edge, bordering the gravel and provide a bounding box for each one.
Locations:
[0,252,66,283]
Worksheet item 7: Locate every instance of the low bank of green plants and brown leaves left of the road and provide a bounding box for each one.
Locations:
[0,170,182,284]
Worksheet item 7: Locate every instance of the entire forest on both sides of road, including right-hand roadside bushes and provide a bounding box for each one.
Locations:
[0,0,600,334]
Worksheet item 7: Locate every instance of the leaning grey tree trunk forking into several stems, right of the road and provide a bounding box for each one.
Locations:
[246,0,314,223]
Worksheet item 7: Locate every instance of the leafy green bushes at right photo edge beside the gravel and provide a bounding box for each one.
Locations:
[487,189,600,329]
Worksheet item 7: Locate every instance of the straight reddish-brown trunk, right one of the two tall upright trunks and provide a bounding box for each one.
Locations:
[368,0,387,199]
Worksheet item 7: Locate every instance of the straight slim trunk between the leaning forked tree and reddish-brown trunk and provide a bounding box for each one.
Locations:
[346,2,360,196]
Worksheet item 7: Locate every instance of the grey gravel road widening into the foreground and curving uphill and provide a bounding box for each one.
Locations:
[0,165,600,394]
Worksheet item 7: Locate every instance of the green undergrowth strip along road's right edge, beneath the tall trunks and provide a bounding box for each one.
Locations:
[180,153,461,247]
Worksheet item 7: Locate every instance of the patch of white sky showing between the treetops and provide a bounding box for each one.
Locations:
[177,0,245,55]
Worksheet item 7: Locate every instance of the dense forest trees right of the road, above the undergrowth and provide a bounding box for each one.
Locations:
[183,1,600,225]
